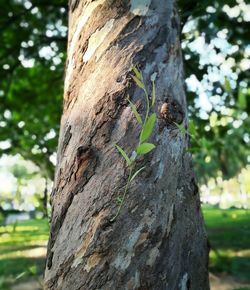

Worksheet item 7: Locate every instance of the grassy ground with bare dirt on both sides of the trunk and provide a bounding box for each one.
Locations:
[0,207,250,290]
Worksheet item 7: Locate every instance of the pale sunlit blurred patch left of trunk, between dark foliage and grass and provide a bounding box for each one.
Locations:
[0,155,51,217]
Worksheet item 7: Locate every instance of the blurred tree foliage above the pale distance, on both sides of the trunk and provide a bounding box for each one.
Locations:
[0,0,250,181]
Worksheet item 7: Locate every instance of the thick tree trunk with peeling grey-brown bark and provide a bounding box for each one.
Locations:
[45,0,209,290]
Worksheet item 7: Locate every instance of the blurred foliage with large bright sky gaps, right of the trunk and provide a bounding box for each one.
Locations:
[178,0,250,183]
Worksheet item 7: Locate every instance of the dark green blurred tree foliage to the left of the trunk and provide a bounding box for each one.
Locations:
[0,0,67,179]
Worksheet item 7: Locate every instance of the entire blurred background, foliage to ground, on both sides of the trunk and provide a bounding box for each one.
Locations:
[0,0,250,290]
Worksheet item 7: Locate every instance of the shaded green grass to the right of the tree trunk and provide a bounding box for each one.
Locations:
[203,208,250,282]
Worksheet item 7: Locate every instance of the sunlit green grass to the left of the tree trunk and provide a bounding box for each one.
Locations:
[0,220,49,290]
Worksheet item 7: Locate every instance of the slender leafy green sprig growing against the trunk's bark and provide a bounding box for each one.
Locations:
[111,66,156,222]
